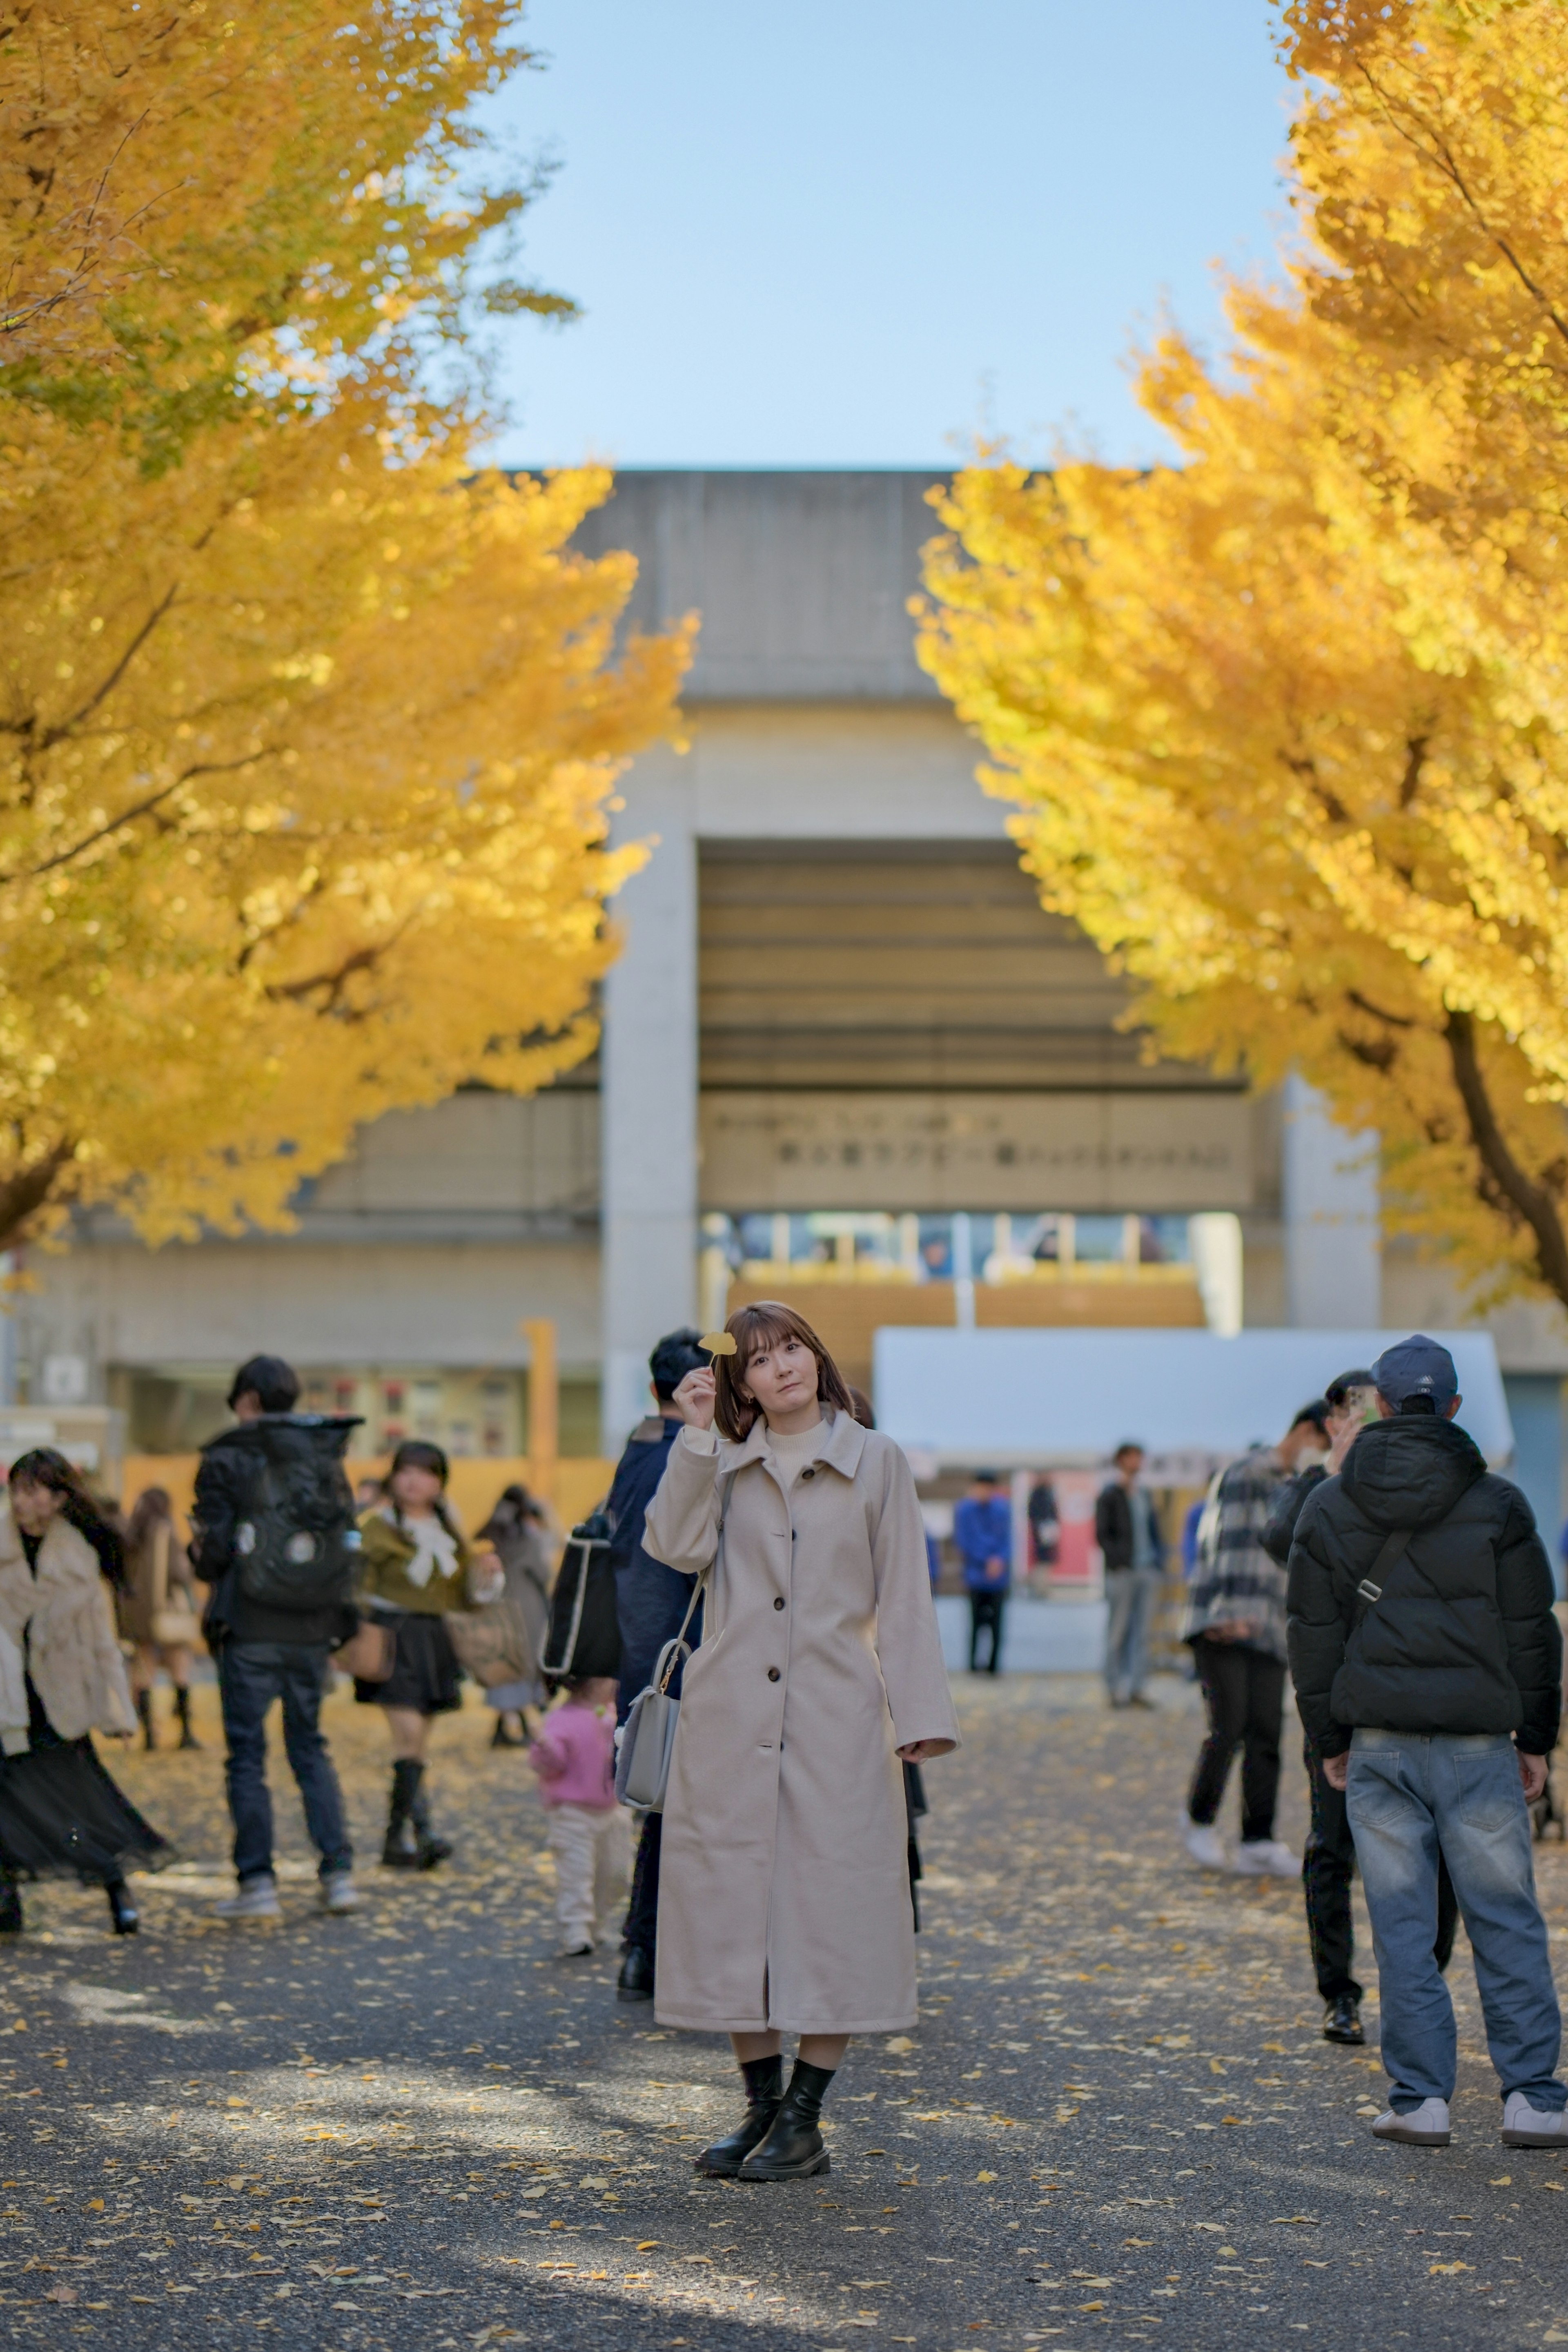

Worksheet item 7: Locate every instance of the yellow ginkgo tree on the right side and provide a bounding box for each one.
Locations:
[922,0,1568,1303]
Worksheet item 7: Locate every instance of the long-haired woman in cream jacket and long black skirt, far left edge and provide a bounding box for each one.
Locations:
[0,1447,169,1936]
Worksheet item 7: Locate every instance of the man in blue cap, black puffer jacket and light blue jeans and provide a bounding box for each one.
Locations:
[1288,1336,1568,2147]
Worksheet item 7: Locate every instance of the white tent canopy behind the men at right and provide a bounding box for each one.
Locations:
[877,1329,1514,1468]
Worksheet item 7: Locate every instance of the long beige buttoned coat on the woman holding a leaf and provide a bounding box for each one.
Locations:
[642,1413,959,2035]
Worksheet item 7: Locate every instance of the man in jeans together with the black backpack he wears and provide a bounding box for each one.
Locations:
[193,1355,360,1919]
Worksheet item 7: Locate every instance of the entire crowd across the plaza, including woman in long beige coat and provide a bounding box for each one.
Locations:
[0,1303,1568,2180]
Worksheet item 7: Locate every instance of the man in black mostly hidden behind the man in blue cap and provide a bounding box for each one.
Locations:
[1263,1371,1460,2046]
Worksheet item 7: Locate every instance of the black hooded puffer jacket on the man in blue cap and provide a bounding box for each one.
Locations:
[1286,1413,1563,1757]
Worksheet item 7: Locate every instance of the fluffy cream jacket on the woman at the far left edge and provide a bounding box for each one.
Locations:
[0,1503,136,1755]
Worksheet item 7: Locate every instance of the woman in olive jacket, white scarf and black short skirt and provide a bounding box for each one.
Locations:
[355,1437,503,1870]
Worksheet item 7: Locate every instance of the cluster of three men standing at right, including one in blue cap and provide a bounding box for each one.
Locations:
[1161,1336,1568,2147]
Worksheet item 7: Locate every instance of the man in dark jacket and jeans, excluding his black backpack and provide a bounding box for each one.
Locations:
[190,1355,360,1919]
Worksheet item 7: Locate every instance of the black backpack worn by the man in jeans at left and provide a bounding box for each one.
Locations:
[233,1413,360,1611]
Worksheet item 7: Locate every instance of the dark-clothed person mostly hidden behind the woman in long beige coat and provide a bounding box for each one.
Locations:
[604,1329,708,2002]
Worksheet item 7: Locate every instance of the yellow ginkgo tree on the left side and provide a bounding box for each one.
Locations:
[0,0,686,1246]
